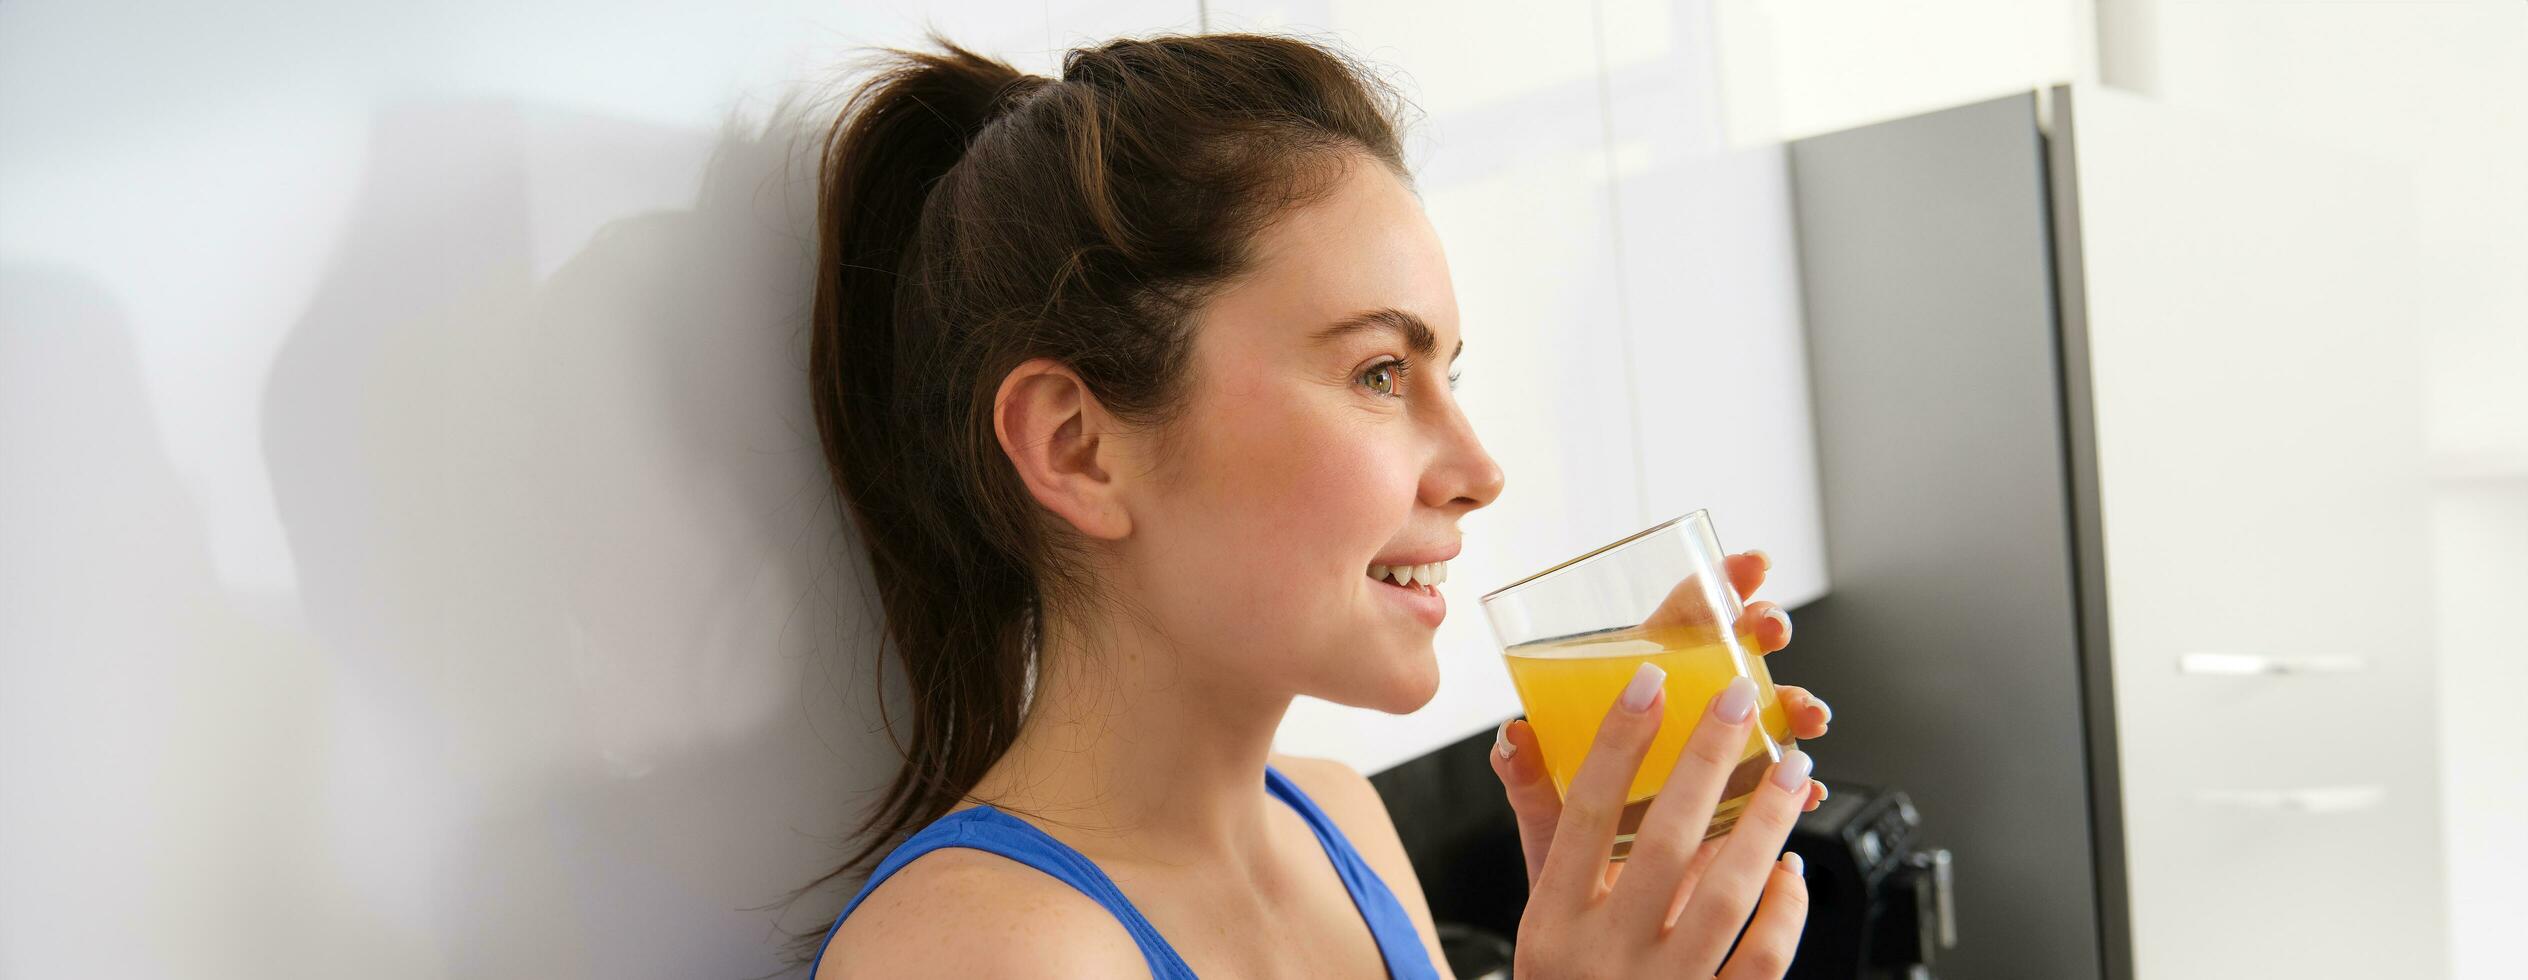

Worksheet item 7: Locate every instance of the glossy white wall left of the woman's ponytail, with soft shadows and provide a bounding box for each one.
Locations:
[0,0,1193,977]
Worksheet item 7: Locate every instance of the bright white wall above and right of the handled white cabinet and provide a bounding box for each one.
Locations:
[2101,0,2528,980]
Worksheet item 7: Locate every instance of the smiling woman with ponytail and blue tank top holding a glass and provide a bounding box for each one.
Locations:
[809,35,1825,977]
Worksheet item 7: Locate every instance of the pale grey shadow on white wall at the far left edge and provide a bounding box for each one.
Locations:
[0,263,369,977]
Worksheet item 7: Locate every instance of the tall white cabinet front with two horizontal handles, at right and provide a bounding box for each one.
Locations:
[2055,88,2445,980]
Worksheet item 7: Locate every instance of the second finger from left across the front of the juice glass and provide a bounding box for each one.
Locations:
[1615,677,1754,932]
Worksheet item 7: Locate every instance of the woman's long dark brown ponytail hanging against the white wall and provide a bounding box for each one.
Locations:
[809,35,1049,904]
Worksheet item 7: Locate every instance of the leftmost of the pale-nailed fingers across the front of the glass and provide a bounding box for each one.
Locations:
[1537,662,1668,907]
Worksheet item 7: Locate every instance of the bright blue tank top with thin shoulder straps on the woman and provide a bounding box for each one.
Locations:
[809,765,1438,980]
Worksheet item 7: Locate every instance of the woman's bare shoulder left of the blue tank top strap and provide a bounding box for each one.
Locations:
[817,846,1148,980]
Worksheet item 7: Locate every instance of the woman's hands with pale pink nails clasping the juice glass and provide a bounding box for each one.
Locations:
[1492,551,1830,977]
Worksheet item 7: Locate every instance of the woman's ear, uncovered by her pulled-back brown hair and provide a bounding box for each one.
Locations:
[991,356,1133,541]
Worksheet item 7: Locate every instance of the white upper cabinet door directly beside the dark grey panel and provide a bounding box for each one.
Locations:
[1598,0,1825,608]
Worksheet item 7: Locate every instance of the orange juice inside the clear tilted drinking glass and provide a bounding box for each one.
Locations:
[1504,626,1795,856]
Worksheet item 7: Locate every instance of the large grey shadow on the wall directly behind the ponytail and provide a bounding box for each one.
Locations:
[245,101,897,977]
